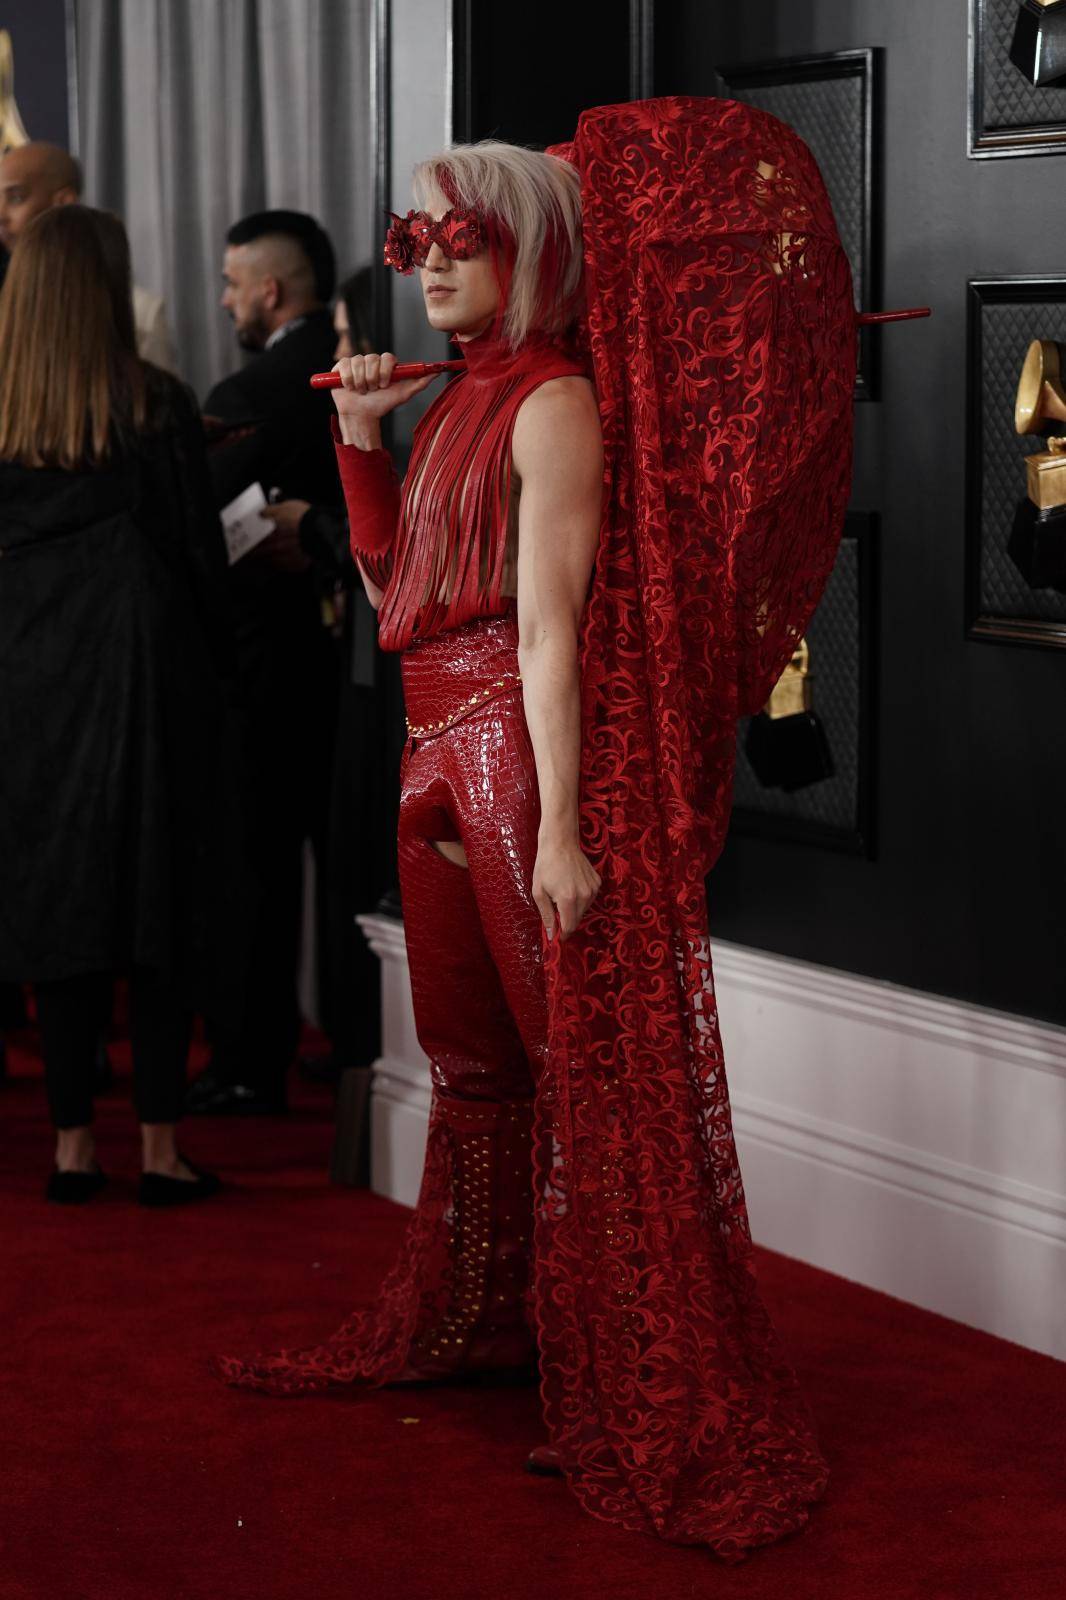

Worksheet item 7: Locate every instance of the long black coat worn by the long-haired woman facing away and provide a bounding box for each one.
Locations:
[0,370,236,997]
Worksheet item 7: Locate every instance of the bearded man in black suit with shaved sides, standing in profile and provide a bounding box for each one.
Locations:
[189,211,341,1114]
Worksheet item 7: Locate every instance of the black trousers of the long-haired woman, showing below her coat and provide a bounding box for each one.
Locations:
[34,966,192,1128]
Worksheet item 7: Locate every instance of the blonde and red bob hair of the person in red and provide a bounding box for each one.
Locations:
[413,139,581,349]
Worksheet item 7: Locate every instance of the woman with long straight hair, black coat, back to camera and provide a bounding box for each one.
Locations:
[0,205,226,1205]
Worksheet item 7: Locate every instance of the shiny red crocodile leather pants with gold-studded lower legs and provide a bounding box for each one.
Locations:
[399,610,547,1378]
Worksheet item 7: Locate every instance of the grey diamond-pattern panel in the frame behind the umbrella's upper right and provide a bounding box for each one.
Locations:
[728,75,866,306]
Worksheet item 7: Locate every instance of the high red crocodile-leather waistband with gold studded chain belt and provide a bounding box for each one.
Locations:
[400,606,522,739]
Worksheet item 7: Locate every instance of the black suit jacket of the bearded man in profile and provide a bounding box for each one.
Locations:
[203,310,341,507]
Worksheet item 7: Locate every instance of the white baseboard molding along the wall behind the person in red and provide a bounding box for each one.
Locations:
[352,917,1066,1358]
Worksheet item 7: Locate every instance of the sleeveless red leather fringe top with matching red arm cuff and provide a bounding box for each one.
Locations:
[333,334,587,650]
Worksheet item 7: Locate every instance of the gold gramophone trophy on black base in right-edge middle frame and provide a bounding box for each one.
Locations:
[1007,339,1066,594]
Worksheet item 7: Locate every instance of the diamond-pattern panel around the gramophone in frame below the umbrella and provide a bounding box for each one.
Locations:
[733,538,863,834]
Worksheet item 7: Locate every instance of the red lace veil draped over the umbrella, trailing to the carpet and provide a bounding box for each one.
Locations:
[535,99,856,1557]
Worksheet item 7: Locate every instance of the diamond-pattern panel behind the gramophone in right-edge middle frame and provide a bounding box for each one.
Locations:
[970,301,1066,622]
